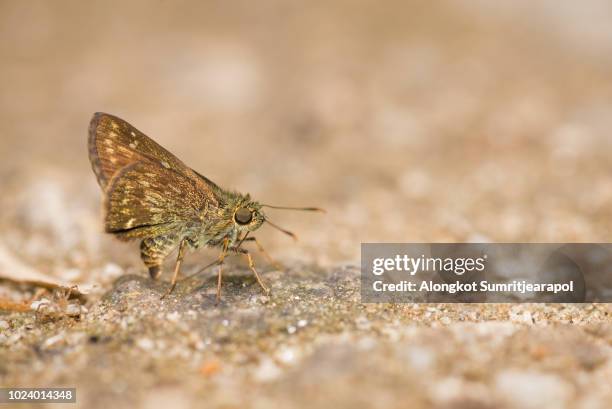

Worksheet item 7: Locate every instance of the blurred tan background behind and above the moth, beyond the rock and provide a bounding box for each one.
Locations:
[0,0,612,278]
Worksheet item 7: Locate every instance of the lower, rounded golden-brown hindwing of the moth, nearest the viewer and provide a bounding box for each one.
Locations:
[104,161,218,239]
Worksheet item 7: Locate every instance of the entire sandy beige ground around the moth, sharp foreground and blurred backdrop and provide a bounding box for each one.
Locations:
[0,1,612,409]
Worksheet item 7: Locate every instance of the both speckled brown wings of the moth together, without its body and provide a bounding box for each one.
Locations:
[89,113,219,240]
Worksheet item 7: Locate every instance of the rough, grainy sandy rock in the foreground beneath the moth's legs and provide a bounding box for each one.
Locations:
[0,267,612,408]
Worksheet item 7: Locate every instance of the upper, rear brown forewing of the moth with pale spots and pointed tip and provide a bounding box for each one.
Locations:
[89,112,193,189]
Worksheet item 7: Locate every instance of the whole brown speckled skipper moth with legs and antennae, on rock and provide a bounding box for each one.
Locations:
[89,112,321,300]
